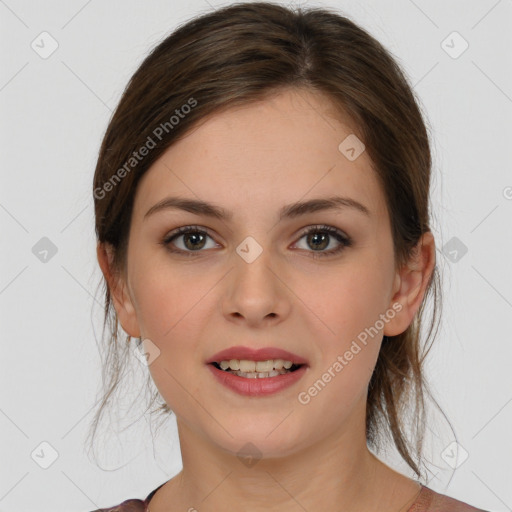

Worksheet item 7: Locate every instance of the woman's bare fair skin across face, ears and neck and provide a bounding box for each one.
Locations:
[98,89,435,512]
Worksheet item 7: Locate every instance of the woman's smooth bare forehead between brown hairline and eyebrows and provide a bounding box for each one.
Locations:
[135,90,386,221]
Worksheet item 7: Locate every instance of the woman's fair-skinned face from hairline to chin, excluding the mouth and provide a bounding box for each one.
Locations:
[102,90,426,457]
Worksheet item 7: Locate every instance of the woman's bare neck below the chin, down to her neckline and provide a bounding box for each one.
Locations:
[151,406,419,512]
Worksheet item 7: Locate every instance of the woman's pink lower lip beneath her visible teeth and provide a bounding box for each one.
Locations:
[207,364,307,396]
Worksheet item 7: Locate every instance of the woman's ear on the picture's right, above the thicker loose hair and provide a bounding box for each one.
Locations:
[384,231,436,336]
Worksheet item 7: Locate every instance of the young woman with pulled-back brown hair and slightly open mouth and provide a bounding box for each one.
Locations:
[88,2,488,512]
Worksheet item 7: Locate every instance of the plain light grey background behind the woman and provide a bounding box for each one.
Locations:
[0,0,512,512]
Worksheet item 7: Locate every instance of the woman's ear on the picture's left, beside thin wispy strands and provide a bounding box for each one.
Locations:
[96,242,140,338]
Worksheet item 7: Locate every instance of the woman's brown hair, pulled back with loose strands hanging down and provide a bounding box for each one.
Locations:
[93,2,440,476]
